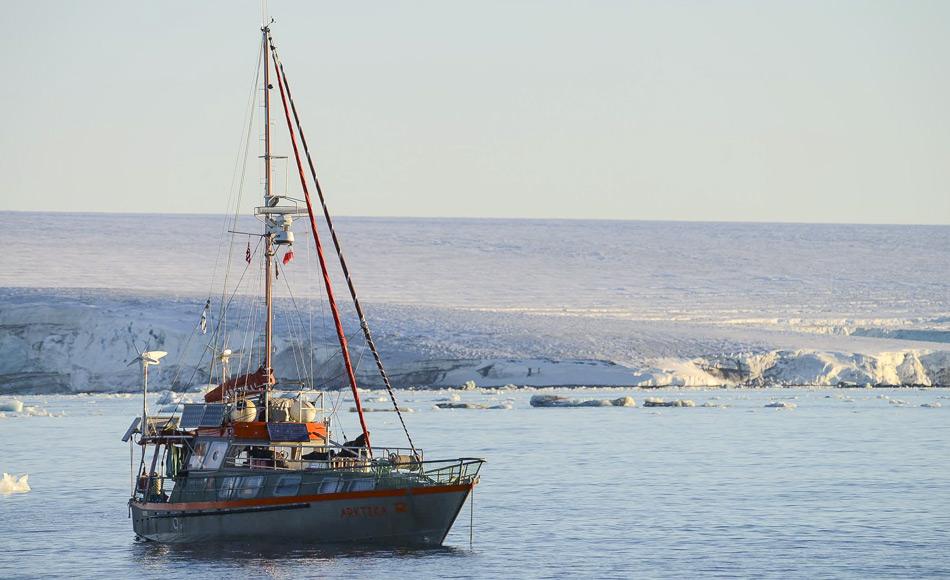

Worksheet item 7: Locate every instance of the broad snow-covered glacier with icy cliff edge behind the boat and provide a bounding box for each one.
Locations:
[0,213,950,394]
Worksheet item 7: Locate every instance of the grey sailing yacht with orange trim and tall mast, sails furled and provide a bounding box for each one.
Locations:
[123,23,484,546]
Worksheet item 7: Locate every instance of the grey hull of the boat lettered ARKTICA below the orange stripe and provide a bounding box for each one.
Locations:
[129,484,474,546]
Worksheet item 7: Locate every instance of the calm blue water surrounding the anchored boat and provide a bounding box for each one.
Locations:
[0,389,950,578]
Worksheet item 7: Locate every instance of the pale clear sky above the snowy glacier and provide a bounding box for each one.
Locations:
[0,0,950,224]
